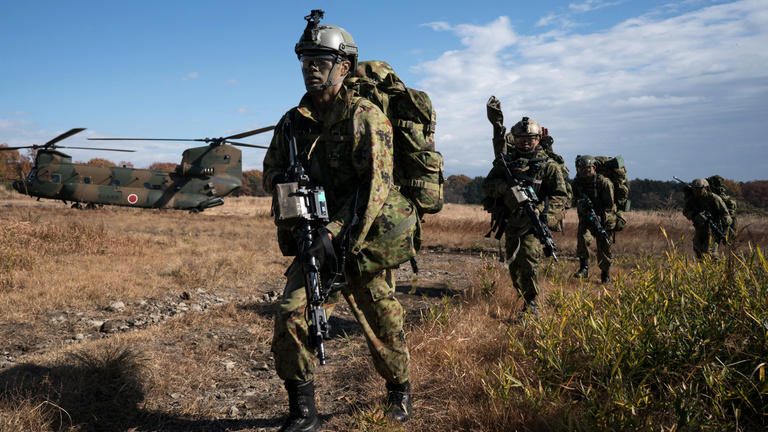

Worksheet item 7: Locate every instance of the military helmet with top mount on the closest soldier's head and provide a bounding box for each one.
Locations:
[294,9,357,71]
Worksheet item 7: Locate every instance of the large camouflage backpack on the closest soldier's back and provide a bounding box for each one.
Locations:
[344,60,444,215]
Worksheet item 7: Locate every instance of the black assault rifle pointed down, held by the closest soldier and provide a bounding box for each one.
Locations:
[276,116,331,365]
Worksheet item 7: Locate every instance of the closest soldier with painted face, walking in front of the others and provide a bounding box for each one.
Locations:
[264,11,417,431]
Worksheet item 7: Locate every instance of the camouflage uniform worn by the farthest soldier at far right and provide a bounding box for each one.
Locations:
[683,191,733,258]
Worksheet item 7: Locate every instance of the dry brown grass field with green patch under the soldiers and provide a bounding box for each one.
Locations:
[0,195,768,431]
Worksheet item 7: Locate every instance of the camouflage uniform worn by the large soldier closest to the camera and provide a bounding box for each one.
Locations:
[264,88,413,384]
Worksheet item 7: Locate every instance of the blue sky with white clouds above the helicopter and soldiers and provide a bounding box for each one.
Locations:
[0,0,768,180]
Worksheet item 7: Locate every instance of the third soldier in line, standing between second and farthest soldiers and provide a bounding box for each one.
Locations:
[573,155,616,283]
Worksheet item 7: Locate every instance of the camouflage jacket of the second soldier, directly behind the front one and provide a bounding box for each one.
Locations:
[483,148,570,232]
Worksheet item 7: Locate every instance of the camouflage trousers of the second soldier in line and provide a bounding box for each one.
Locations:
[504,231,543,302]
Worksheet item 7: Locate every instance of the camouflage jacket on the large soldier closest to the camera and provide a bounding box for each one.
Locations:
[263,87,407,250]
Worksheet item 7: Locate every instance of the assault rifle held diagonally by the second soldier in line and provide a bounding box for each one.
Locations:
[486,154,557,261]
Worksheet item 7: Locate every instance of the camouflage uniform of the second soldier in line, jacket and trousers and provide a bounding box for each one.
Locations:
[483,147,569,303]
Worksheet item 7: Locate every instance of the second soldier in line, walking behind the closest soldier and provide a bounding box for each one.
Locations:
[483,117,569,313]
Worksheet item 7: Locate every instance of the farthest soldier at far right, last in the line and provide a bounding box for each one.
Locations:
[683,179,733,259]
